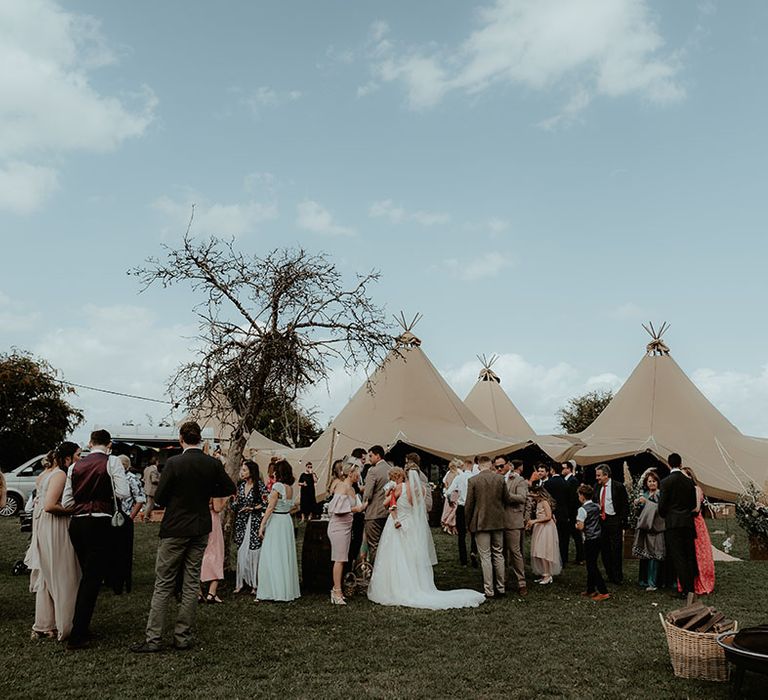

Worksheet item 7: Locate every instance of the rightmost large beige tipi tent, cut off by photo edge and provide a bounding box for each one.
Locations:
[575,325,768,499]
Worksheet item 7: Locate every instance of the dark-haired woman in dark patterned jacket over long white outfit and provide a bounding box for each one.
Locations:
[230,459,269,596]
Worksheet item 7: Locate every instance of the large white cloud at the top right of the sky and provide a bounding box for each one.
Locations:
[372,0,685,115]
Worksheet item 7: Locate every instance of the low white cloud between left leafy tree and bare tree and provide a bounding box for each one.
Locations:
[32,305,197,440]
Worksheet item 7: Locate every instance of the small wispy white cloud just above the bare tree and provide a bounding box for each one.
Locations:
[152,195,278,238]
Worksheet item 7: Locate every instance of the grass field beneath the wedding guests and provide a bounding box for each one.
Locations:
[0,518,768,700]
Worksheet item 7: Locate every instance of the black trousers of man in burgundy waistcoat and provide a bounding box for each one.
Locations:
[69,516,114,642]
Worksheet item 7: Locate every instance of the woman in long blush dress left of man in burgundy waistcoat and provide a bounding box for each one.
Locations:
[24,442,80,641]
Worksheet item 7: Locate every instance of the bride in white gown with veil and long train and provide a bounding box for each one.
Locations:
[368,454,485,610]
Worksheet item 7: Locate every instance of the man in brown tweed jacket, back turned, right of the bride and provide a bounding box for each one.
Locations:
[464,457,505,598]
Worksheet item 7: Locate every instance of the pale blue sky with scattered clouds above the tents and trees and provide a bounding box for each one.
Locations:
[0,0,768,446]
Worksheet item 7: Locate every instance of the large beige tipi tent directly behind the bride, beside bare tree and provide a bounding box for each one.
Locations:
[296,319,528,494]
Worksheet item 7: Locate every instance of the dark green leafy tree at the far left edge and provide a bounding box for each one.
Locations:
[0,349,83,468]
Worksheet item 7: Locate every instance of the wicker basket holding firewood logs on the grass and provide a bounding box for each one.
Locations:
[659,613,738,681]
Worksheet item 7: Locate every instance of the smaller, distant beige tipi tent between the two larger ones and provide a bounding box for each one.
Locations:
[464,355,578,461]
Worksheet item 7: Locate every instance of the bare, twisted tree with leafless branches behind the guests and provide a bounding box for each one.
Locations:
[129,227,391,477]
